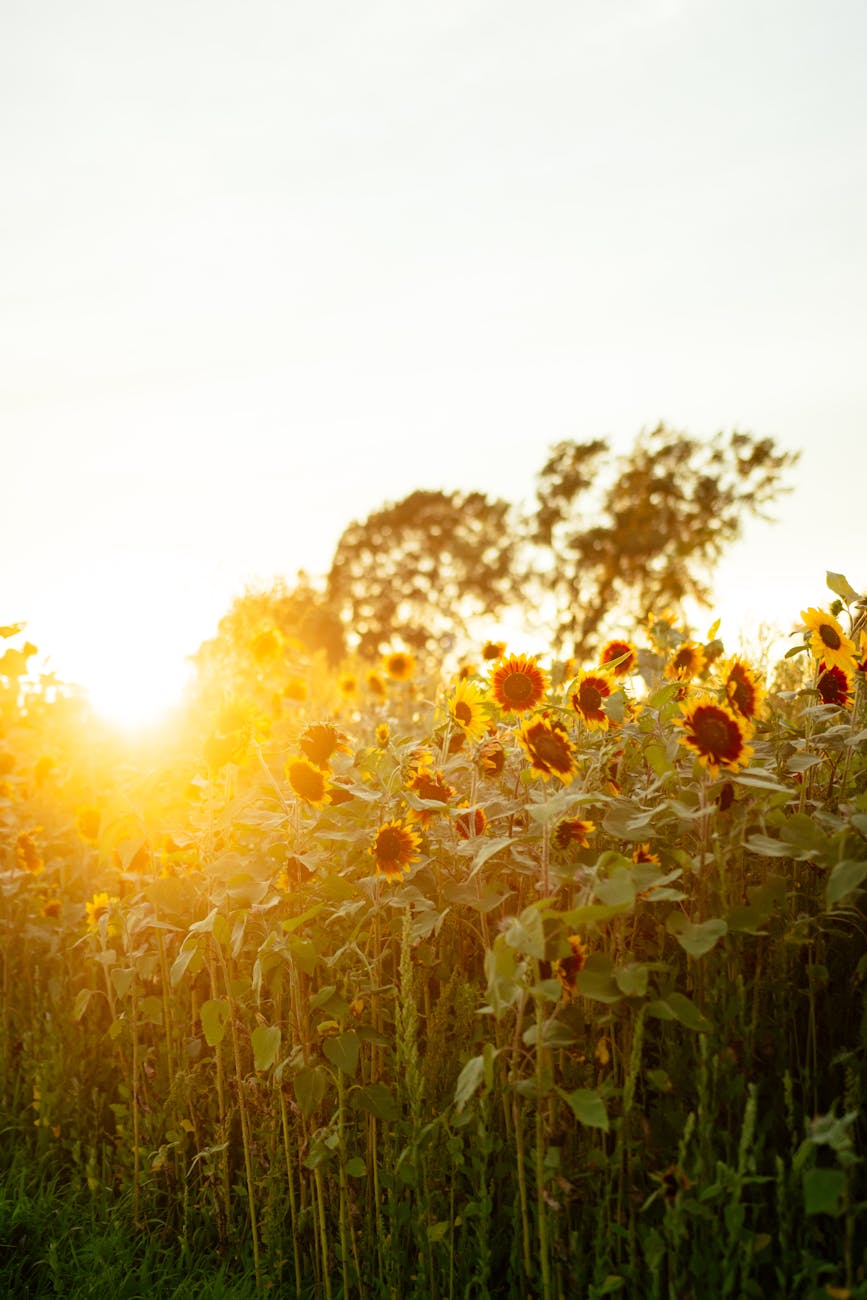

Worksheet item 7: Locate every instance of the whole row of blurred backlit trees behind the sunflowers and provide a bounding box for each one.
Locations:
[200,424,798,662]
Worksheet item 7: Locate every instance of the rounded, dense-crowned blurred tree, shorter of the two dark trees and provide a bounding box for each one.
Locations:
[328,490,517,657]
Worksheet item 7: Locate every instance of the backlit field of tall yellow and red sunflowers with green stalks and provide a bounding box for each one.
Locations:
[0,575,867,1300]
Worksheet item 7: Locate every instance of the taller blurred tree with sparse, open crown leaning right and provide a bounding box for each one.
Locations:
[529,424,798,658]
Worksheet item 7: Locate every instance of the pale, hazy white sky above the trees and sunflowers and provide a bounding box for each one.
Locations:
[0,0,867,718]
